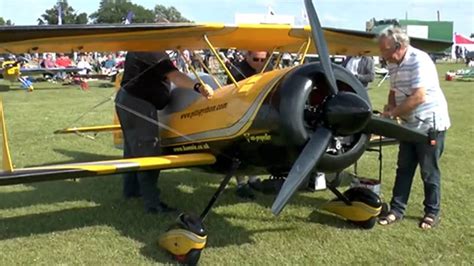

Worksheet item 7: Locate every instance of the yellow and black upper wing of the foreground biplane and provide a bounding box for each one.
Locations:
[0,23,451,55]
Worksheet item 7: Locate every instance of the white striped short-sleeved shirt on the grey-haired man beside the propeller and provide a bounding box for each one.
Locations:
[388,46,451,131]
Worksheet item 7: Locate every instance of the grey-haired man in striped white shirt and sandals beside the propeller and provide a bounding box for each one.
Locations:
[378,28,451,229]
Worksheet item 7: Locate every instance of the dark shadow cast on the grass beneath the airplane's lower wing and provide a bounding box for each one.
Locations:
[0,171,300,263]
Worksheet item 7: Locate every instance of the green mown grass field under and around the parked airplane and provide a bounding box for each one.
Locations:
[0,62,474,265]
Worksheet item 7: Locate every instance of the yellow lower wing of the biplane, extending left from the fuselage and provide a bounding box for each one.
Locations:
[0,153,216,186]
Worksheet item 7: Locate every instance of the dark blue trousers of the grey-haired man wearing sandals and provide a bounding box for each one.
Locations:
[390,131,446,217]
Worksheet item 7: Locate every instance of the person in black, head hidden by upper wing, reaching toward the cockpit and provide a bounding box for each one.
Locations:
[115,52,213,214]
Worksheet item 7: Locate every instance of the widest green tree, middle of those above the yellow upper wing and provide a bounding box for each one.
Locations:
[89,0,155,23]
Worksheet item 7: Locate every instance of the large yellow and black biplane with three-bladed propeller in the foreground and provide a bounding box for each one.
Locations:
[0,0,451,263]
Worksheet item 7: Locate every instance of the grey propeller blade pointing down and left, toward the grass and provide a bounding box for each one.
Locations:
[272,127,332,215]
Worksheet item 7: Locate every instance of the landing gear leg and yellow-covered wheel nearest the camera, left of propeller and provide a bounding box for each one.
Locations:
[158,159,240,265]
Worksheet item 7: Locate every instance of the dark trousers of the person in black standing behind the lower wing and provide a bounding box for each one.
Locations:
[115,89,160,209]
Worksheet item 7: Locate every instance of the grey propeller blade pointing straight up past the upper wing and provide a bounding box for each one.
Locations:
[304,0,338,94]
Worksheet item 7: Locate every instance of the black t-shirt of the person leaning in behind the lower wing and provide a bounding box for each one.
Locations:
[120,52,177,110]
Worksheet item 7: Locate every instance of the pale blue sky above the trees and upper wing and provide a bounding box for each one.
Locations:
[0,0,474,36]
